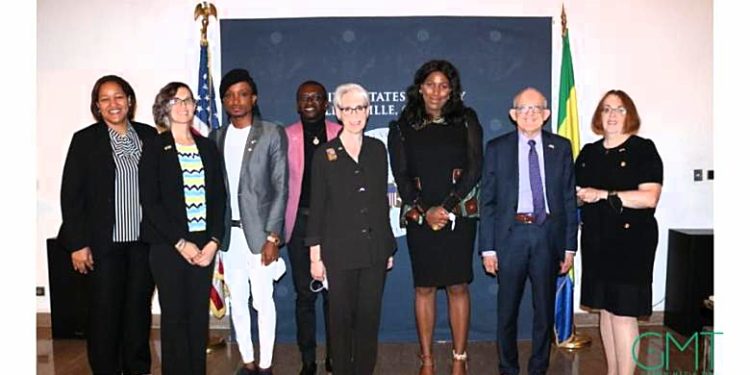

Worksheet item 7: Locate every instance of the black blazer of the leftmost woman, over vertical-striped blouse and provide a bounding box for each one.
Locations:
[58,122,156,255]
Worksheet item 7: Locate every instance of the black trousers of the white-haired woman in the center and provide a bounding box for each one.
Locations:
[326,262,386,375]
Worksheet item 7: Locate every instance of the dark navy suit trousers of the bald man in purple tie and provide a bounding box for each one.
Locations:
[497,223,560,375]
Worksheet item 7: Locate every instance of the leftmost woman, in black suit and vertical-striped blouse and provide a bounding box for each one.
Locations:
[58,75,156,374]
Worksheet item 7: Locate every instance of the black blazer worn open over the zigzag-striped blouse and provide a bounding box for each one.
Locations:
[138,131,227,246]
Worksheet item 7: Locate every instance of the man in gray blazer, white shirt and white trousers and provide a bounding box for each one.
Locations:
[211,69,288,375]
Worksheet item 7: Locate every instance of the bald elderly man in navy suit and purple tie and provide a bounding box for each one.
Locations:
[479,88,577,374]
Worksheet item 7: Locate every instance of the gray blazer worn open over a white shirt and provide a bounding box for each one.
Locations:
[210,117,289,254]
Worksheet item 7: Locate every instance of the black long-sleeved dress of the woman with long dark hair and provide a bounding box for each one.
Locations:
[388,108,482,287]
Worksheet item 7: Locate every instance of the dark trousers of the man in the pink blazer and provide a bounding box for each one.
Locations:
[287,210,331,364]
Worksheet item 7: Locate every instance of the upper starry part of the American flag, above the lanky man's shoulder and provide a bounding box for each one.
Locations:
[193,43,221,137]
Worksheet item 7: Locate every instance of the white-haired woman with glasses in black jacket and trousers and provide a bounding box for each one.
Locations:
[305,83,396,375]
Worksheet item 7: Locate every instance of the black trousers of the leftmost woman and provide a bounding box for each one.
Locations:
[86,242,154,375]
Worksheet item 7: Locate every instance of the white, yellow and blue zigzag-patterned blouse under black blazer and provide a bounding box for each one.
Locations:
[175,143,206,232]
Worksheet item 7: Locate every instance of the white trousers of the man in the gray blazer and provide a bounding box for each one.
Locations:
[228,227,276,368]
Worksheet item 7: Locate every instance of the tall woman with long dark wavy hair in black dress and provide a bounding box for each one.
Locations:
[388,60,482,375]
